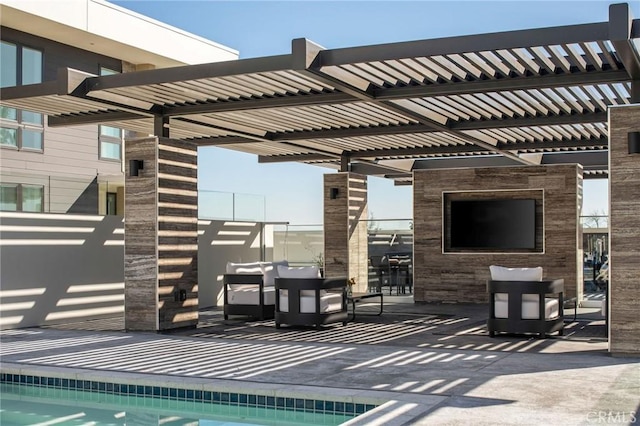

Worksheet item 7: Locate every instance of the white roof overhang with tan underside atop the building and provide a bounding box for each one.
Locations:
[0,0,238,68]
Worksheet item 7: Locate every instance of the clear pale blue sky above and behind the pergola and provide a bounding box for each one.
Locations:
[111,0,624,225]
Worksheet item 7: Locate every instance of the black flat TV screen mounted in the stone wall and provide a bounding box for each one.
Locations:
[448,199,536,250]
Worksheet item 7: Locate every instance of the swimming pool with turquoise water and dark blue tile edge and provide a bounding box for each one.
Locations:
[0,373,375,426]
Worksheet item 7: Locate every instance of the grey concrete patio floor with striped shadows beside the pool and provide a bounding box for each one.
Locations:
[0,295,640,425]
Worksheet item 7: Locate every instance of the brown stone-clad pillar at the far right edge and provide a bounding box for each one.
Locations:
[609,104,640,356]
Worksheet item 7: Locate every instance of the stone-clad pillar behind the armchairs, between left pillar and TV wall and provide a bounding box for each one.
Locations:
[324,172,368,292]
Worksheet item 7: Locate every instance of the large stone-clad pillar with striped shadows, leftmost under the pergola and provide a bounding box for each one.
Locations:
[125,138,198,331]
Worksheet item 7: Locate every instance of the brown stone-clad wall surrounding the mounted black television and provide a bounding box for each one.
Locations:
[413,165,582,303]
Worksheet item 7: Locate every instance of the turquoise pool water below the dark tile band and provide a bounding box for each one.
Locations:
[0,383,356,426]
